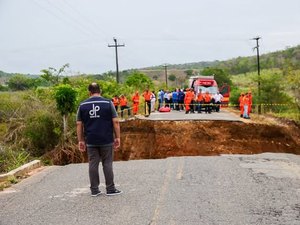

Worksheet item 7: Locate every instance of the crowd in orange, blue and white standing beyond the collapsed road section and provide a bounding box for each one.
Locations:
[112,88,252,119]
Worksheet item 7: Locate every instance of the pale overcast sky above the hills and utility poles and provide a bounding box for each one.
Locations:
[0,0,300,74]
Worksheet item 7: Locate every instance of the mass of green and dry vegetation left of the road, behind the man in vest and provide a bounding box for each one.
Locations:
[0,69,159,172]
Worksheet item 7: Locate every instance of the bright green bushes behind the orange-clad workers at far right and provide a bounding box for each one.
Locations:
[231,69,300,122]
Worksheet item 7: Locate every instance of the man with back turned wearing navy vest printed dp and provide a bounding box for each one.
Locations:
[76,83,122,197]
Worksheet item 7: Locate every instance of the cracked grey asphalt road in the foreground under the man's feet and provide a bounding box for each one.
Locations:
[0,153,300,225]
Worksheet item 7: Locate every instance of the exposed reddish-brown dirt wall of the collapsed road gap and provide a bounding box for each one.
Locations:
[115,120,300,160]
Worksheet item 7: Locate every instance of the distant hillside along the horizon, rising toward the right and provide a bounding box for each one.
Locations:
[0,45,300,81]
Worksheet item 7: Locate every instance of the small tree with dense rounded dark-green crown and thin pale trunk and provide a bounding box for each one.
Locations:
[54,84,77,140]
